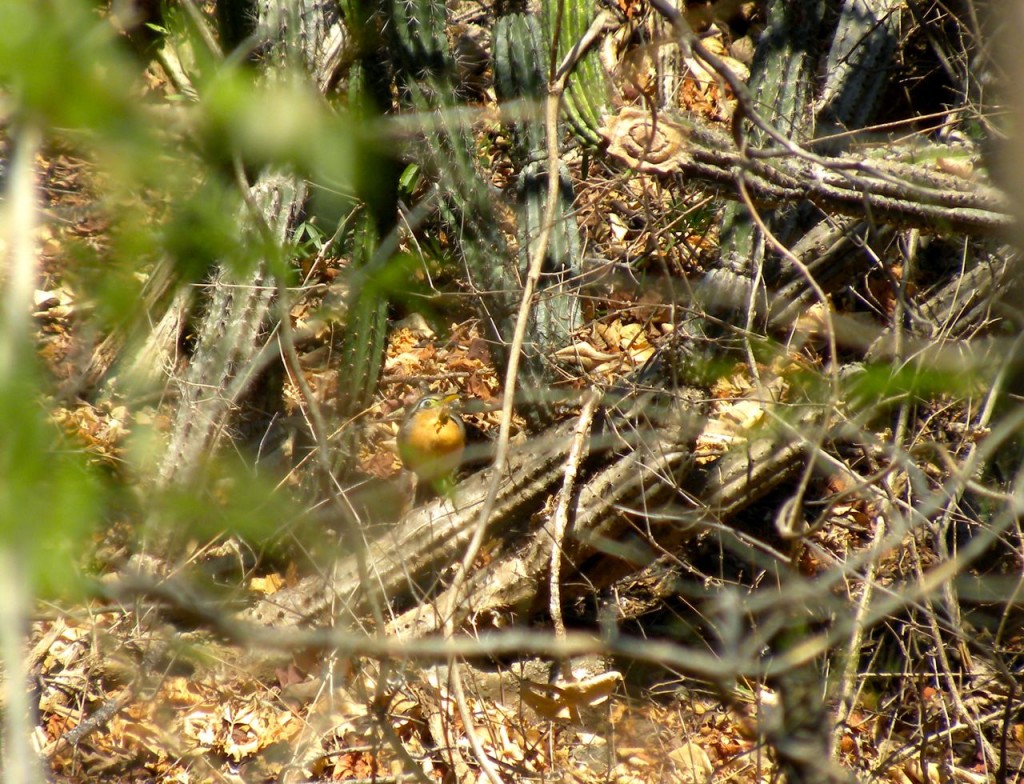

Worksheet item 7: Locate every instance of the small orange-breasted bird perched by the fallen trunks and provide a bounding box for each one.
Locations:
[397,393,466,495]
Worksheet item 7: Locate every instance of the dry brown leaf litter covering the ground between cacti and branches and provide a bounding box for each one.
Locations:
[19,4,1024,784]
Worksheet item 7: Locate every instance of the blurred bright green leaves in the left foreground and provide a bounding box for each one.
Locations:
[0,0,376,596]
